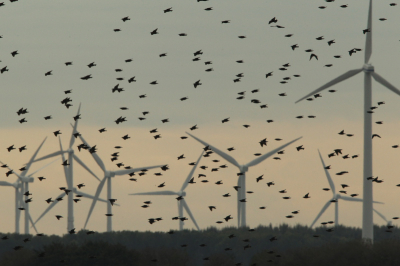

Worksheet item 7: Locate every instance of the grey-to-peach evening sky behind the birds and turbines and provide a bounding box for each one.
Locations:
[0,0,400,235]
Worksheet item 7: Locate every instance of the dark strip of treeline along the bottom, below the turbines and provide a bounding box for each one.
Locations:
[0,224,400,266]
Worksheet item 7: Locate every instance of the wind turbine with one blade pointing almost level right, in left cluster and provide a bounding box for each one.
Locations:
[79,135,163,232]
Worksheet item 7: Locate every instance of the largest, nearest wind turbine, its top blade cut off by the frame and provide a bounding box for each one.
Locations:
[296,0,400,243]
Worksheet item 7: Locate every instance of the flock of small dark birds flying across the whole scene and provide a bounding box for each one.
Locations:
[0,0,400,265]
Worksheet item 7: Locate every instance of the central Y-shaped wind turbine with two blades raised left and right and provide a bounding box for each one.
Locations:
[186,132,302,227]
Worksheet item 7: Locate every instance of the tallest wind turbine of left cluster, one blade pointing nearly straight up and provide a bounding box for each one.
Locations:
[34,104,100,232]
